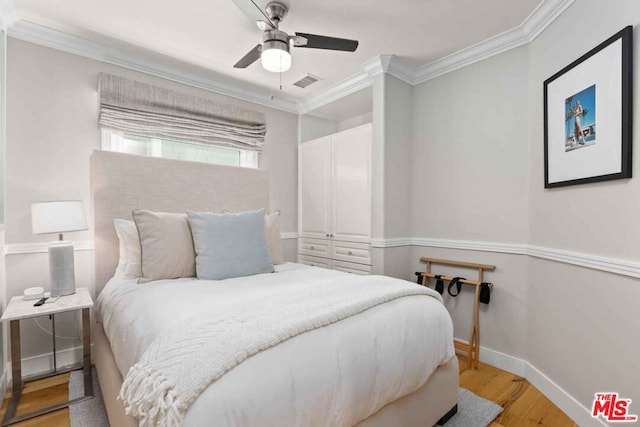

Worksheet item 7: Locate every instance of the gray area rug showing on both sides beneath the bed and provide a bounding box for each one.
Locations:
[69,369,502,427]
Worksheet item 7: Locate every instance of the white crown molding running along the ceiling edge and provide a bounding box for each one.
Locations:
[5,0,575,114]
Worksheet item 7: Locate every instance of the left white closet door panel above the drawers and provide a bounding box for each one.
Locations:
[298,136,331,239]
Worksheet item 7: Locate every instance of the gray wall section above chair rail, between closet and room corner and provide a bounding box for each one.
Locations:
[411,47,529,243]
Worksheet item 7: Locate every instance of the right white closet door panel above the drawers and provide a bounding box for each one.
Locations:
[331,124,371,242]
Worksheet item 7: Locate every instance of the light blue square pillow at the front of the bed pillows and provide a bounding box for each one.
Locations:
[187,209,273,280]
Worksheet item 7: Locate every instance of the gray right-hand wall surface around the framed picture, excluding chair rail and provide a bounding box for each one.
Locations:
[527,0,640,413]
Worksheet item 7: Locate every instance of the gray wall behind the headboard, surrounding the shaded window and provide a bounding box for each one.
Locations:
[6,38,298,362]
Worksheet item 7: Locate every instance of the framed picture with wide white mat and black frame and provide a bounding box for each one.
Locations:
[544,26,633,188]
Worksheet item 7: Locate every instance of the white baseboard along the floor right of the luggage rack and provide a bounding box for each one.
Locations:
[452,340,607,427]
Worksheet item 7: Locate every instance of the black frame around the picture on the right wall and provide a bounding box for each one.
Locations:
[544,25,633,188]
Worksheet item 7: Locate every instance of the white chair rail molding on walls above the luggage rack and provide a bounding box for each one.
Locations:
[371,237,640,278]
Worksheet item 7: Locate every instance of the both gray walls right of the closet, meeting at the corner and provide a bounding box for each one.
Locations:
[411,0,640,408]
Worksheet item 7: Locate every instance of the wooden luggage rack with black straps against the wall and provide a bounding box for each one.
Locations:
[416,257,496,369]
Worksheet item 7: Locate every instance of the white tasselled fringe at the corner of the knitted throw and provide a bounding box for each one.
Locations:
[118,363,184,427]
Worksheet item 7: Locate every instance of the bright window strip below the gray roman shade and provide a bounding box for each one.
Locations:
[102,129,258,168]
